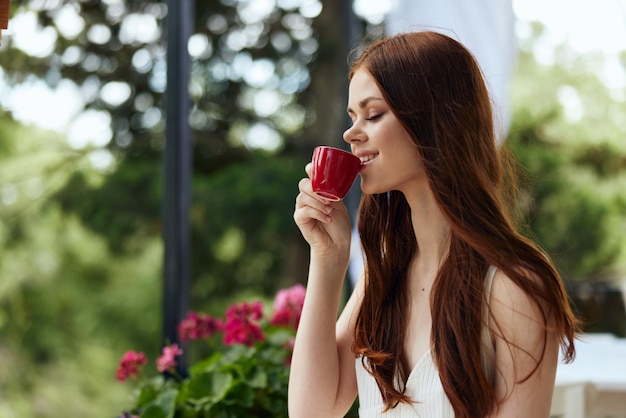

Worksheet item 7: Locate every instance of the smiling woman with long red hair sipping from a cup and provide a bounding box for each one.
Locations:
[289,32,577,418]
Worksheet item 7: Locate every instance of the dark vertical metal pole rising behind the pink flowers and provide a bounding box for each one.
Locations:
[163,0,193,376]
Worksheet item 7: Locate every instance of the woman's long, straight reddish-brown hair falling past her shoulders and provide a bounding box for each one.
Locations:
[350,32,577,418]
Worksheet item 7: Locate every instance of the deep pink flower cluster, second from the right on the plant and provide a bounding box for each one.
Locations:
[223,302,265,347]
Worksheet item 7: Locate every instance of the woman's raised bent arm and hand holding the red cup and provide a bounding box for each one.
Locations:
[289,168,361,418]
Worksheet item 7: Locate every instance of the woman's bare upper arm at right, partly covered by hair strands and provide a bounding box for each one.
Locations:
[490,270,559,418]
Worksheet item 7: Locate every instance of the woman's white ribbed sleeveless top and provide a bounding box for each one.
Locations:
[355,266,496,418]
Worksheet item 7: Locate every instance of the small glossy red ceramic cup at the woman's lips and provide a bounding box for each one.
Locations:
[311,146,361,200]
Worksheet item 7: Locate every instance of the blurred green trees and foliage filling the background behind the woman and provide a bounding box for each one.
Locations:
[0,0,626,418]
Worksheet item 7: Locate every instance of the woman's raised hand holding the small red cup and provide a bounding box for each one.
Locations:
[293,163,352,260]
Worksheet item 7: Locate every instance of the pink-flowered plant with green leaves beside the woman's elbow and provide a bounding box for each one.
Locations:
[116,285,305,418]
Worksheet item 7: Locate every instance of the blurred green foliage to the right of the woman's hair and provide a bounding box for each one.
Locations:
[507,37,626,282]
